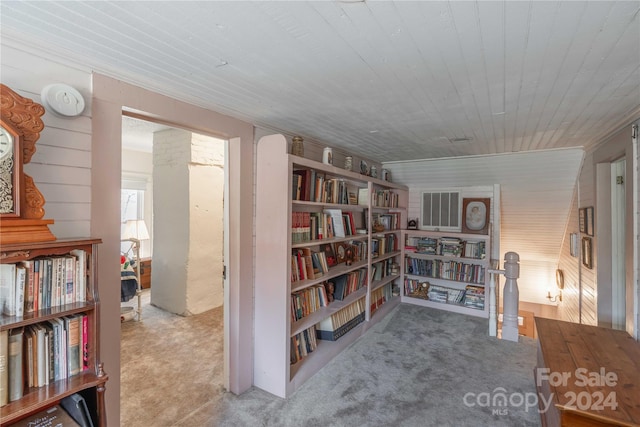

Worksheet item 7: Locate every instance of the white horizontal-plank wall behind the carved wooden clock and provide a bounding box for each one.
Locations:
[0,44,92,238]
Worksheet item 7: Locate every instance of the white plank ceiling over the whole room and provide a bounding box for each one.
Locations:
[0,0,640,161]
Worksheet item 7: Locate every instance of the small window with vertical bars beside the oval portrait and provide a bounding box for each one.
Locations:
[420,191,461,231]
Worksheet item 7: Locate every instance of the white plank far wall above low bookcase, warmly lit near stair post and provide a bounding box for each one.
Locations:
[384,149,583,304]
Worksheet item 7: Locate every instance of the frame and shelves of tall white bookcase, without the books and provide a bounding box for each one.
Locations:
[254,134,408,398]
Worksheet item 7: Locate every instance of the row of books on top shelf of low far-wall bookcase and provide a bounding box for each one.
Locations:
[405,236,486,259]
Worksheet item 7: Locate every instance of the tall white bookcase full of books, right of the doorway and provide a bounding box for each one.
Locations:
[254,135,408,397]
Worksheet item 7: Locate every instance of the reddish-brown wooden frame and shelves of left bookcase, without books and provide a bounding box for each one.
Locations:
[0,239,108,427]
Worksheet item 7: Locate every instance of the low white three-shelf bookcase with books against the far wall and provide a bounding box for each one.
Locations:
[401,230,492,317]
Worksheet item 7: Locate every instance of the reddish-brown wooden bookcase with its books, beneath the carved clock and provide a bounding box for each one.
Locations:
[0,239,107,427]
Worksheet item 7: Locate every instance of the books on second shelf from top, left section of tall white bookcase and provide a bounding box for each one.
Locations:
[291,209,358,244]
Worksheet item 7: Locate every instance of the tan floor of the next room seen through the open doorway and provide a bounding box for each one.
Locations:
[120,289,224,427]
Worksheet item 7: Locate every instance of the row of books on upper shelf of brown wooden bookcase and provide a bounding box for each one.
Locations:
[0,249,87,317]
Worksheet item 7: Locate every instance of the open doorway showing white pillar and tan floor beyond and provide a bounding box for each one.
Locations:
[120,115,227,426]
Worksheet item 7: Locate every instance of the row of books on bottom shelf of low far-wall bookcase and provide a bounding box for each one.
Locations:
[404,278,485,310]
